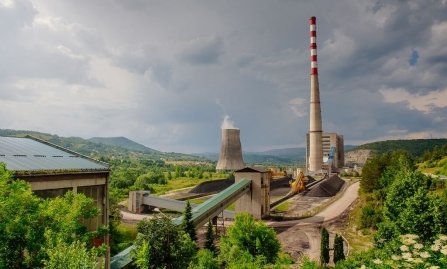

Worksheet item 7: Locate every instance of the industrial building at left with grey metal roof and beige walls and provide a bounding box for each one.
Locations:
[0,137,109,234]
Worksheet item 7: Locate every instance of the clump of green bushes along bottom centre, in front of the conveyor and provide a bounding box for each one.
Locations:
[134,211,292,269]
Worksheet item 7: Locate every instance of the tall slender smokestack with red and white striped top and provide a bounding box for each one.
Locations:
[308,17,323,172]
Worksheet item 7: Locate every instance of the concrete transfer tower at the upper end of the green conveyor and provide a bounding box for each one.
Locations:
[235,171,271,219]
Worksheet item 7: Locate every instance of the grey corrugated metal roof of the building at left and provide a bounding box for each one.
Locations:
[0,137,109,171]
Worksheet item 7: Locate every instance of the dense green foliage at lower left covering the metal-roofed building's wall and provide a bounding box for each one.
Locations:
[0,164,107,268]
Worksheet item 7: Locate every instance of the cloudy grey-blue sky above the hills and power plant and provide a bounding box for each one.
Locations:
[0,0,447,153]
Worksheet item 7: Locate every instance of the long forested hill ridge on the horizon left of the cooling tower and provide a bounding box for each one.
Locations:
[0,129,200,160]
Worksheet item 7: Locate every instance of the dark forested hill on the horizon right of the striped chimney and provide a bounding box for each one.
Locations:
[353,138,447,157]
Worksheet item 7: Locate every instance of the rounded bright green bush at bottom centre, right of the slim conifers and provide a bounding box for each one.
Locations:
[219,213,280,263]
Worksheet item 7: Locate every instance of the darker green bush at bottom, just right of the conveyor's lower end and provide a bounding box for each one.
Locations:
[133,216,197,269]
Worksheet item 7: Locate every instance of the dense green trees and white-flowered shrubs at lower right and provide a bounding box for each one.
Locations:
[303,146,447,269]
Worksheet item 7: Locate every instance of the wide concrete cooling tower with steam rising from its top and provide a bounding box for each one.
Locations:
[216,129,245,171]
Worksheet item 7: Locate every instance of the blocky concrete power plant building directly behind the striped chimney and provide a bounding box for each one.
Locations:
[306,133,345,169]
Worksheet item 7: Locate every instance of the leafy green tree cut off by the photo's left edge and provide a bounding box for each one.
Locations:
[0,163,46,268]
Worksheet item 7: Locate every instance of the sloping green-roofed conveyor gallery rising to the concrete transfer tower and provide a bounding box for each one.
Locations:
[110,179,251,269]
